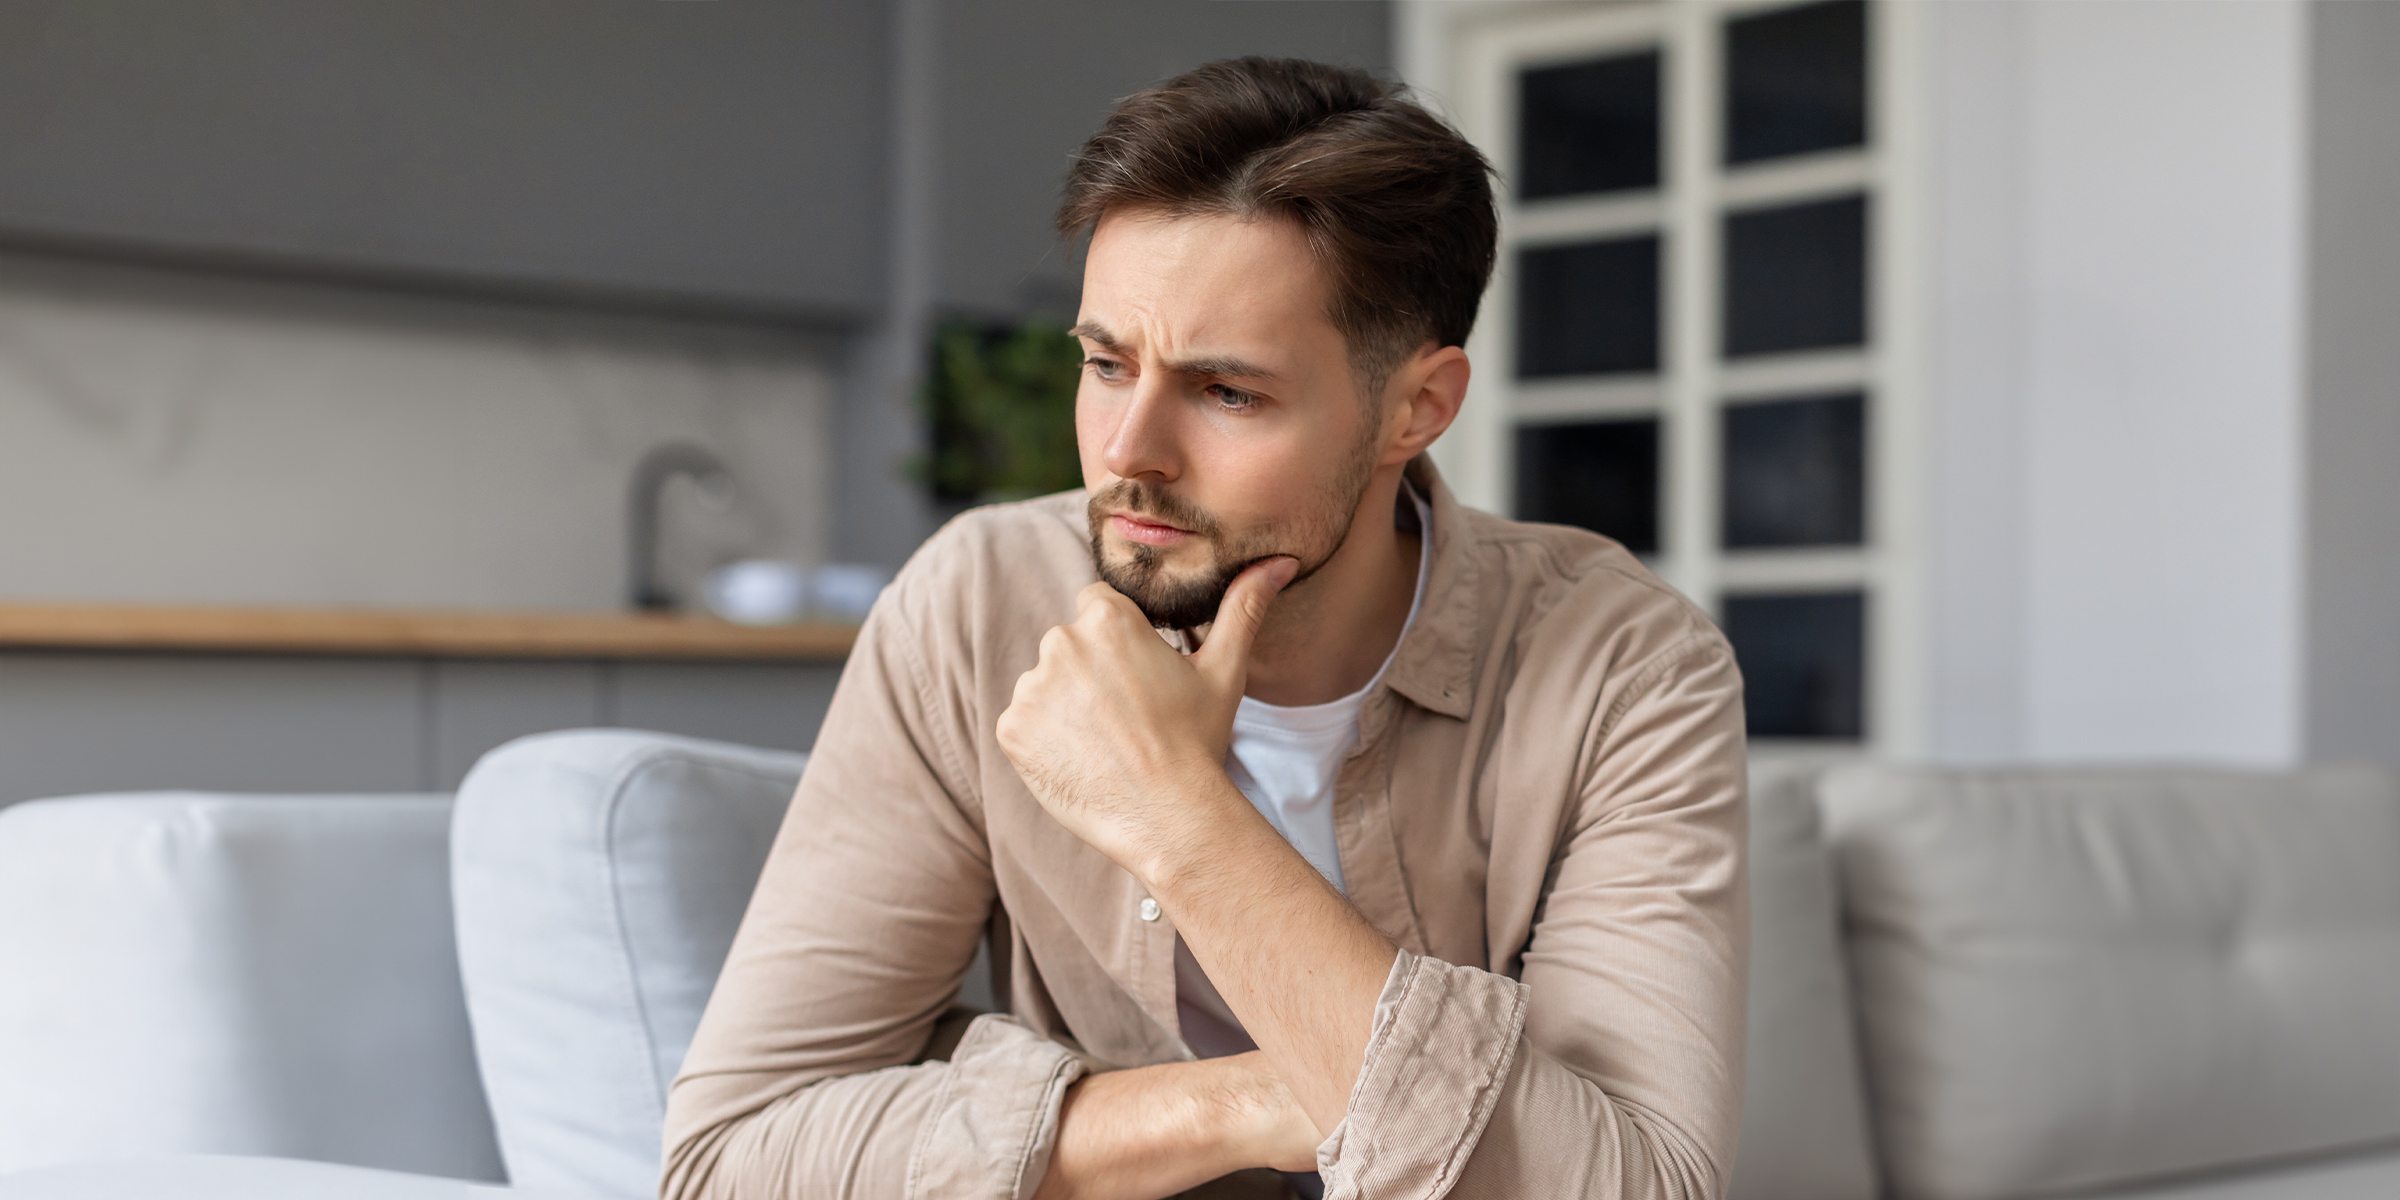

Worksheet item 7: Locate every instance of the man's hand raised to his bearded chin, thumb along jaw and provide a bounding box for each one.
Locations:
[998,557,1298,881]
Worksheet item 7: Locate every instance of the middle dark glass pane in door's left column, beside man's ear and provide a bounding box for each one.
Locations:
[1517,235,1658,379]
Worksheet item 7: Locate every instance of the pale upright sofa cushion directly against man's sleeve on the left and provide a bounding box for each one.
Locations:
[451,730,806,1200]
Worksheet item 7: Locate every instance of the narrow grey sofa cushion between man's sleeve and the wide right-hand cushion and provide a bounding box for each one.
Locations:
[1728,758,1879,1200]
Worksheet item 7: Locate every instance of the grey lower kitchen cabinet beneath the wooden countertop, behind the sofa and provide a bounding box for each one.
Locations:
[0,650,840,806]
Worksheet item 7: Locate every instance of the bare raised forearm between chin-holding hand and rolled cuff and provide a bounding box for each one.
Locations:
[1142,780,1397,1135]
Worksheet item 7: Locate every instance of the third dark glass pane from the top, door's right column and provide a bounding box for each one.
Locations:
[1726,396,1867,547]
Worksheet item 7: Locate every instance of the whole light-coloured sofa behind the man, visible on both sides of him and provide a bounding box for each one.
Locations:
[0,730,2400,1200]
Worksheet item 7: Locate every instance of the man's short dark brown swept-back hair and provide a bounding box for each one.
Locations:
[1058,58,1500,398]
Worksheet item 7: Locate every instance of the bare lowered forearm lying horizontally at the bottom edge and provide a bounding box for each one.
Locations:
[1034,1054,1313,1200]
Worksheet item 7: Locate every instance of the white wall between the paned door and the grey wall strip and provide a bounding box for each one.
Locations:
[1922,0,2306,763]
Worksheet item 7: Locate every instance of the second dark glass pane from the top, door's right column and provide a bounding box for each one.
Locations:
[1726,197,1867,355]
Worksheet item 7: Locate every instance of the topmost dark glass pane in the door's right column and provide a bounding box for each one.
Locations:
[1726,0,1867,163]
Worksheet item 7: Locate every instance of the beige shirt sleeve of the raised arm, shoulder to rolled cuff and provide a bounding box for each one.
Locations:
[1318,631,1747,1200]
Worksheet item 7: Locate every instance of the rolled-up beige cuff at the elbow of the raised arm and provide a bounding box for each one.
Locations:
[1318,950,1526,1200]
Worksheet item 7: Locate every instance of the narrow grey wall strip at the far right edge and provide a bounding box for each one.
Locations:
[2304,0,2400,766]
